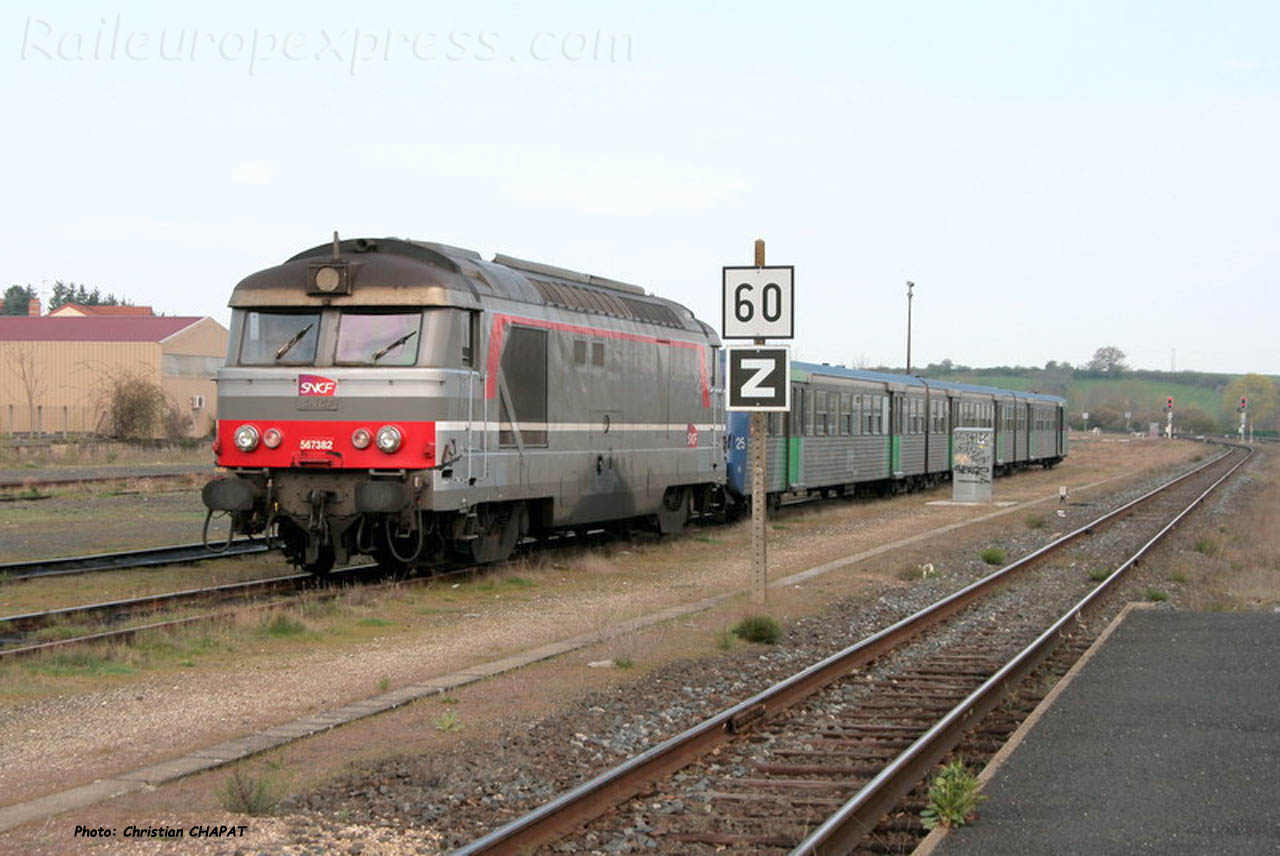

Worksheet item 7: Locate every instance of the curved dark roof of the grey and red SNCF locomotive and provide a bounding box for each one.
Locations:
[229,238,714,337]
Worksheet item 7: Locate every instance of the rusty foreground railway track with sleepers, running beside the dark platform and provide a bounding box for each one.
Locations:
[456,449,1251,856]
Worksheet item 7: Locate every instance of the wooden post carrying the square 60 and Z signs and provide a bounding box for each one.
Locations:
[721,238,795,604]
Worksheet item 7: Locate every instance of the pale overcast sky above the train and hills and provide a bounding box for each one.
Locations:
[0,0,1280,374]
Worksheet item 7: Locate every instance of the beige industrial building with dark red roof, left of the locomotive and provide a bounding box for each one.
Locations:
[0,312,227,436]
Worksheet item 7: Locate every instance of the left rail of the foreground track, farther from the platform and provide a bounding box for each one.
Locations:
[452,449,1239,856]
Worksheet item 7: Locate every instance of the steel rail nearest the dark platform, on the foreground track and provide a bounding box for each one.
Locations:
[791,449,1253,856]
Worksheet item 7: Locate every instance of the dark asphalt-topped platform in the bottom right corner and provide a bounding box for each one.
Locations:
[923,609,1280,856]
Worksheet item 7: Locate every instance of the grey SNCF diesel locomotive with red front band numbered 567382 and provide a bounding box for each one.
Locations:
[204,235,724,572]
